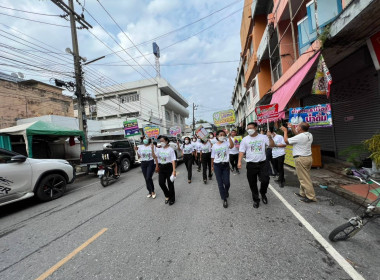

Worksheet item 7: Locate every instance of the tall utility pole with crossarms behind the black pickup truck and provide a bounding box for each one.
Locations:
[51,0,93,150]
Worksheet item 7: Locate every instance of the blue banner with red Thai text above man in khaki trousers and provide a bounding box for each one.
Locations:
[289,104,333,128]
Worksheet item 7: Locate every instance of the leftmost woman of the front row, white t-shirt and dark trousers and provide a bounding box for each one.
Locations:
[136,136,156,198]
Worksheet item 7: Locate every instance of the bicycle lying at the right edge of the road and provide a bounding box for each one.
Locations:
[329,169,380,242]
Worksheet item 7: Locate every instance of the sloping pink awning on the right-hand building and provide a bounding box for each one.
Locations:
[271,53,319,112]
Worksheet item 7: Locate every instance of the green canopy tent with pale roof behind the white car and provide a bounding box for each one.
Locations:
[0,121,87,157]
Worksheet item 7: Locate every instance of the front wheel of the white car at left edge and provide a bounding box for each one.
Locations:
[36,174,66,201]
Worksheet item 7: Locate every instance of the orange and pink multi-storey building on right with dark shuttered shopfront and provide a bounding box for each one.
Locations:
[236,0,380,158]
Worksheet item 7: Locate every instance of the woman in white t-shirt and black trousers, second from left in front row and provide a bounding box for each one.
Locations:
[154,136,177,205]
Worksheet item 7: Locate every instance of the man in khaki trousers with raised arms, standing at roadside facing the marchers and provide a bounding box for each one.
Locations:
[281,122,317,203]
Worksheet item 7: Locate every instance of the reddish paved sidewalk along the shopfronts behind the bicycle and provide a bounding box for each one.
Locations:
[285,162,380,207]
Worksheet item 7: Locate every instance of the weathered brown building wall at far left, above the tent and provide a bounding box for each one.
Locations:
[0,73,74,128]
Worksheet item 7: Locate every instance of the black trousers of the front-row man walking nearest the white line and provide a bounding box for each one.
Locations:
[247,161,269,202]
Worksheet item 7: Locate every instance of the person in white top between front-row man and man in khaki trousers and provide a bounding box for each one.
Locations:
[269,127,286,188]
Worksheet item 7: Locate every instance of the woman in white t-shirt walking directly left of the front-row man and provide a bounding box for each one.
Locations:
[211,130,234,208]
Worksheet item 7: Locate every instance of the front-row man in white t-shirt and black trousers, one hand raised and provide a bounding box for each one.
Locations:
[238,122,274,208]
